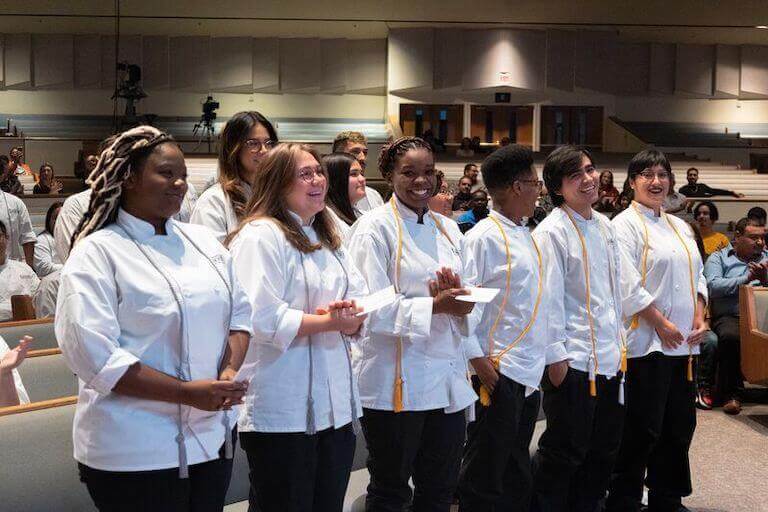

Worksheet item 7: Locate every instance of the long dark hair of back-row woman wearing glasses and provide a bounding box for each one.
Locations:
[219,111,277,220]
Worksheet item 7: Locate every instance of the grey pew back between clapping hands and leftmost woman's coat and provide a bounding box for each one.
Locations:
[19,348,77,402]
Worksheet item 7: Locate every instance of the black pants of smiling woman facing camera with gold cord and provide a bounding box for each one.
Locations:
[362,409,466,512]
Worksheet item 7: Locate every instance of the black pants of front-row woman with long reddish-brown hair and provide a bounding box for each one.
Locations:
[240,424,355,512]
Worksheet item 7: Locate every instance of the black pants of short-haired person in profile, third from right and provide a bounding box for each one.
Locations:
[459,375,539,512]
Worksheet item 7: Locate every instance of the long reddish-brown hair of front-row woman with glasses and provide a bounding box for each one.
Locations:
[226,143,341,253]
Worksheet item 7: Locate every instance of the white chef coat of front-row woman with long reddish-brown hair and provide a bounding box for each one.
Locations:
[230,212,367,432]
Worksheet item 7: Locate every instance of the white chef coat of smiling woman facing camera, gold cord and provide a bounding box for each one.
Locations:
[348,196,477,413]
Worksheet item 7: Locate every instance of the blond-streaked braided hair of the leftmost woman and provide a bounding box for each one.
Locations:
[71,126,174,247]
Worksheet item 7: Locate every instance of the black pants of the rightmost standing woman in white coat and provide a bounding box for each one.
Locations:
[607,352,696,512]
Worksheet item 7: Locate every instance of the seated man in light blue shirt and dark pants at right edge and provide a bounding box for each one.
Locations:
[704,218,768,414]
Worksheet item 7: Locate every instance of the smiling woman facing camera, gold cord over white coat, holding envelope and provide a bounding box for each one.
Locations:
[348,137,482,512]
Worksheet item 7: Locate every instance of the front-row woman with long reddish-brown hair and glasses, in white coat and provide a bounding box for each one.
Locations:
[230,144,367,512]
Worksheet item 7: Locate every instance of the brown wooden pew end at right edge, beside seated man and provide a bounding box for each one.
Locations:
[739,286,768,385]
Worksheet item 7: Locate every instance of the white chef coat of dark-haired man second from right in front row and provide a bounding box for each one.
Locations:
[533,206,653,377]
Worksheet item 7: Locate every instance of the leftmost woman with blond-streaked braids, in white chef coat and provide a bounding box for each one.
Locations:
[56,126,251,512]
